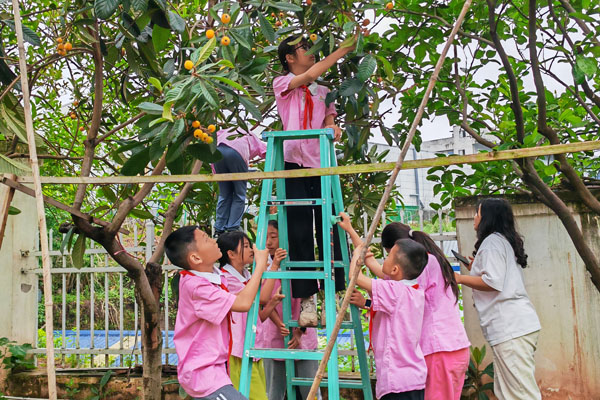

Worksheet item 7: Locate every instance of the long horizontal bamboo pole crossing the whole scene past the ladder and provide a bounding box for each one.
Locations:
[17,141,600,185]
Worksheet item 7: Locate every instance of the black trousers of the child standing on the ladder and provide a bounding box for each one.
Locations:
[285,162,346,298]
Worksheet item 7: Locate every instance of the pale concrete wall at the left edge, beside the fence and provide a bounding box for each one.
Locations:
[0,185,38,344]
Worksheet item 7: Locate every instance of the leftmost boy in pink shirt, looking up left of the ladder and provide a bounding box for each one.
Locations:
[165,226,268,400]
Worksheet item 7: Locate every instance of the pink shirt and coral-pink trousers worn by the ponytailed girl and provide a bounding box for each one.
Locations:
[417,254,470,400]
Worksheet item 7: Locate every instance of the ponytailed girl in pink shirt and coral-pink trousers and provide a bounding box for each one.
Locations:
[340,213,470,400]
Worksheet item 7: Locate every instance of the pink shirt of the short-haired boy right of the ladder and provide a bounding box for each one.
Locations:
[371,279,427,398]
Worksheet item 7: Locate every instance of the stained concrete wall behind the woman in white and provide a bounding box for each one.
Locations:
[456,197,600,399]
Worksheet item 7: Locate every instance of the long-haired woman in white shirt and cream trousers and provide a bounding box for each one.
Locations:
[456,199,541,400]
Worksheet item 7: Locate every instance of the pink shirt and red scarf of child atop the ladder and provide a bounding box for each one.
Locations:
[273,72,337,168]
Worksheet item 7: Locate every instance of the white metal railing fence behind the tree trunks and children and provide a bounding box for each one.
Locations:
[30,212,456,370]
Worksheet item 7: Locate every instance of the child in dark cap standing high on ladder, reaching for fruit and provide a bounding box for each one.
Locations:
[273,36,354,326]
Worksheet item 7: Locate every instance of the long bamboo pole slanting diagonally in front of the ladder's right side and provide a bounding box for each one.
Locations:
[306,0,472,400]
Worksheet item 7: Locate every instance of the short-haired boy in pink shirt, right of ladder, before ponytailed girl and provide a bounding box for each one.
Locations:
[351,239,427,400]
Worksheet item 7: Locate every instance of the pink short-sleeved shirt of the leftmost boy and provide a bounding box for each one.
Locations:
[173,269,236,397]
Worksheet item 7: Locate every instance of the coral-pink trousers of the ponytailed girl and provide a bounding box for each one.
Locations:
[425,347,469,400]
